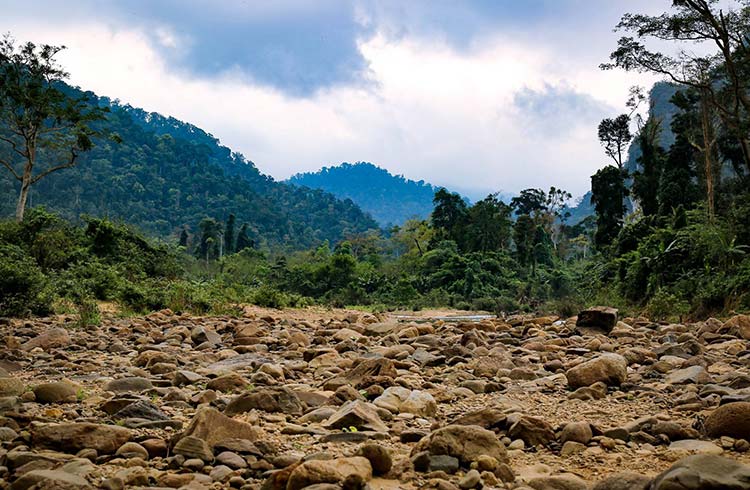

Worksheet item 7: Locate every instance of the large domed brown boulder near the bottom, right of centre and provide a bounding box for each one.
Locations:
[411,425,507,466]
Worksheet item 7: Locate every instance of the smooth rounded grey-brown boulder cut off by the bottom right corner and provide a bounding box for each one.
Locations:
[651,454,750,490]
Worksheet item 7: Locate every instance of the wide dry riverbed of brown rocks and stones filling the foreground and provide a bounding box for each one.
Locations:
[0,307,750,490]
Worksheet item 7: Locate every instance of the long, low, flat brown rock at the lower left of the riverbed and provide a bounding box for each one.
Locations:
[31,422,131,454]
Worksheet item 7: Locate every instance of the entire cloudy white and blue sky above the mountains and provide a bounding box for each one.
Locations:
[0,0,670,199]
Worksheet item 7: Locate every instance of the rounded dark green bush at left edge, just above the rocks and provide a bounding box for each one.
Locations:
[0,243,53,317]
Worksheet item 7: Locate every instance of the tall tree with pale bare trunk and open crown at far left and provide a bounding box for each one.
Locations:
[0,35,113,221]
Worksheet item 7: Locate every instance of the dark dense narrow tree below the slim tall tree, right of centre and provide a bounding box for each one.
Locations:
[591,165,627,248]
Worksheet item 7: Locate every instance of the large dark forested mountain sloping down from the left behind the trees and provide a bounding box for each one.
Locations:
[0,86,377,249]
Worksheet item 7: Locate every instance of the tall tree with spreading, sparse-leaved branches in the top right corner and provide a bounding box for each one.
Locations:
[601,0,750,175]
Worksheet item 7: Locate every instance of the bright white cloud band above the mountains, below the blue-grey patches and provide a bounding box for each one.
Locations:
[4,16,650,194]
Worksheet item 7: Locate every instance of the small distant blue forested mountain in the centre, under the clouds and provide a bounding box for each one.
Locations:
[288,162,452,226]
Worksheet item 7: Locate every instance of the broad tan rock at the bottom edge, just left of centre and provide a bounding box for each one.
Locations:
[286,456,372,490]
